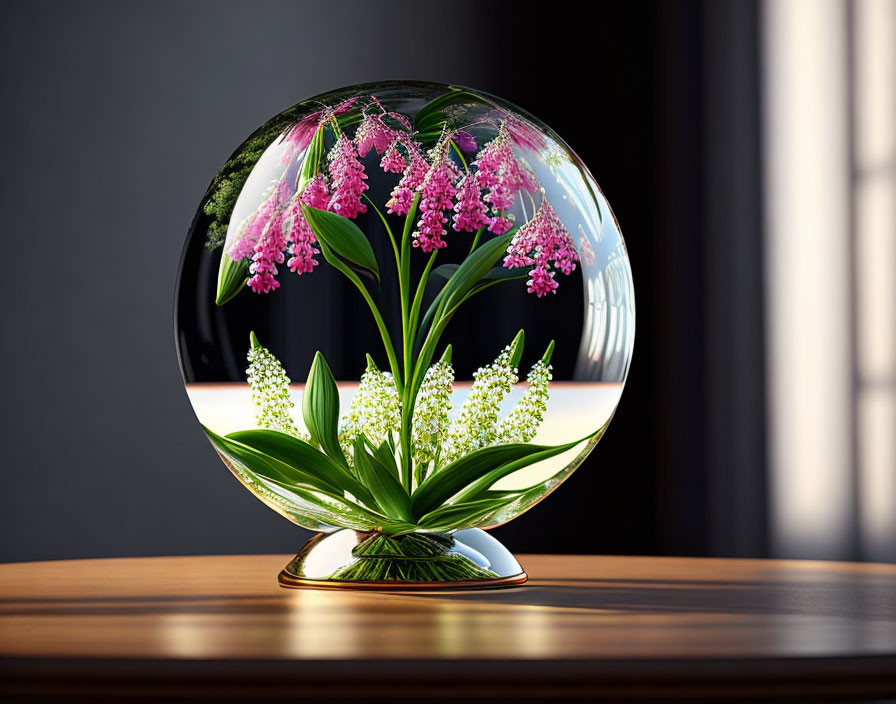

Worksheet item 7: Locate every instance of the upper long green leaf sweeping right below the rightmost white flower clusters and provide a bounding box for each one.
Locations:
[411,440,582,516]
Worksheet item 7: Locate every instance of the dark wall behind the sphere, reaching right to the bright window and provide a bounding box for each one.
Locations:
[0,0,766,561]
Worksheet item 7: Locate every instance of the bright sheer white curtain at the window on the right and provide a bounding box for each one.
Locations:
[761,0,896,561]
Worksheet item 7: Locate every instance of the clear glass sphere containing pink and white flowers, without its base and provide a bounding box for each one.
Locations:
[175,82,635,536]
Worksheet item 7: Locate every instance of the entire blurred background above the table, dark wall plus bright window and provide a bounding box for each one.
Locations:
[0,0,896,561]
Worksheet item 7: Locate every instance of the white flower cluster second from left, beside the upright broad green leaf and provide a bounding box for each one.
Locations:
[339,361,401,449]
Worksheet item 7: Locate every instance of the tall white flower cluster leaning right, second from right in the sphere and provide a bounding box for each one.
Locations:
[443,345,519,463]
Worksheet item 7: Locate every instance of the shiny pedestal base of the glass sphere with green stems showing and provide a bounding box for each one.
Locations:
[279,528,528,591]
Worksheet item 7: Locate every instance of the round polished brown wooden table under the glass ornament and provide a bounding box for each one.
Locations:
[0,555,896,704]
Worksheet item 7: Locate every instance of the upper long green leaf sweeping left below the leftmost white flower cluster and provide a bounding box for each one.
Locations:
[227,430,367,501]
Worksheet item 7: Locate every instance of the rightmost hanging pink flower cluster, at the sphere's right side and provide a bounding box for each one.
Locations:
[504,199,579,297]
